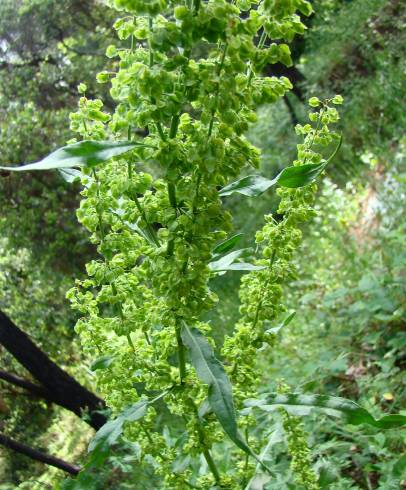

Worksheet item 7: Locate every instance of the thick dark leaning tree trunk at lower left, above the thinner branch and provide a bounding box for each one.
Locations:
[0,311,107,430]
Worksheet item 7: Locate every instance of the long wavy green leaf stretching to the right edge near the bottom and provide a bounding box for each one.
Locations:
[246,393,406,429]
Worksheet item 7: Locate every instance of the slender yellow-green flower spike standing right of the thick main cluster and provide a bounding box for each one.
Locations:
[223,98,342,400]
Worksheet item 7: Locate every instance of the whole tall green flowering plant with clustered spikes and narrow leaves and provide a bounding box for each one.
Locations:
[3,0,405,489]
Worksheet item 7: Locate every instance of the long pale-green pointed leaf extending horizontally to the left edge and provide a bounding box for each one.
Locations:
[0,140,139,172]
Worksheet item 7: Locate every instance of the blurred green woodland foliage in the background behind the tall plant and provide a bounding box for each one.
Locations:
[0,0,406,490]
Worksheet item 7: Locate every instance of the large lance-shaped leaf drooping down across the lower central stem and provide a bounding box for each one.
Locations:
[181,323,270,471]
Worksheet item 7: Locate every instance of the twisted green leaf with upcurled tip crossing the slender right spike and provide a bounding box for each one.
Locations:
[219,137,342,197]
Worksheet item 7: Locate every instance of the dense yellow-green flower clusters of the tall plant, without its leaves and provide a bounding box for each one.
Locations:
[68,0,338,489]
